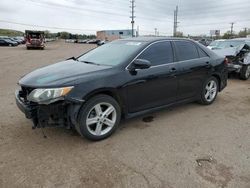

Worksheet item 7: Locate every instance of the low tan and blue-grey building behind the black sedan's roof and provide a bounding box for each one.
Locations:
[96,29,132,41]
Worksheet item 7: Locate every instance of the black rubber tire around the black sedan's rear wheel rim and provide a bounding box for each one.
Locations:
[198,76,219,105]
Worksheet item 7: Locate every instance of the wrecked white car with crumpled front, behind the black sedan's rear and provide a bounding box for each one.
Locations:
[213,38,250,80]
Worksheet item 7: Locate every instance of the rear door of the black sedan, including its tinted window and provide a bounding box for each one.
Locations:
[174,40,212,100]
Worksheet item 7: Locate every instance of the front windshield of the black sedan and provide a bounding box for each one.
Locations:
[78,41,143,66]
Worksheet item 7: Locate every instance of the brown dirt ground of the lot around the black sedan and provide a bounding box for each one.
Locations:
[0,42,250,188]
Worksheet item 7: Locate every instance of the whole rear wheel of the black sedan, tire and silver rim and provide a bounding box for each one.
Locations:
[199,76,219,105]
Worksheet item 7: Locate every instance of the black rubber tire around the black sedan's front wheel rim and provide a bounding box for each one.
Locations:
[75,94,121,141]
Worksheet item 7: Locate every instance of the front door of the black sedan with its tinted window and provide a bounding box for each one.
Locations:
[126,41,177,113]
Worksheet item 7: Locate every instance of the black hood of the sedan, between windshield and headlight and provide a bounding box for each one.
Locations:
[19,60,111,88]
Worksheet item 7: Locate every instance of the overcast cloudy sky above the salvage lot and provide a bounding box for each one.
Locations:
[0,0,250,35]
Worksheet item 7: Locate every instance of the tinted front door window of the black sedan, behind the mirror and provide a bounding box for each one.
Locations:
[138,42,174,66]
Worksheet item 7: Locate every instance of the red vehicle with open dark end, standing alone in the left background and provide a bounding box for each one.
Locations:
[25,30,45,50]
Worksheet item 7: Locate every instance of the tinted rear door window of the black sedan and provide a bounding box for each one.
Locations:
[175,41,199,61]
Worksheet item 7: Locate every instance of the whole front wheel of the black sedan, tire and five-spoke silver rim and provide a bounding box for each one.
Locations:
[76,95,121,141]
